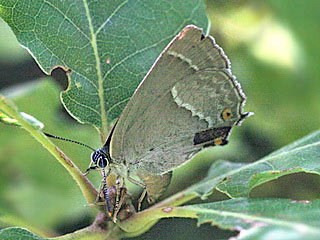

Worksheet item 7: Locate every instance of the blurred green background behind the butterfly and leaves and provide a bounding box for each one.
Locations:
[0,0,320,240]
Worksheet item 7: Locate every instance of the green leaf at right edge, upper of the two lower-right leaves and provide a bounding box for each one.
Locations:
[217,131,320,198]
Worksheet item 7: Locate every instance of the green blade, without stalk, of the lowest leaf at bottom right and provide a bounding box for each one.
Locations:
[190,198,320,239]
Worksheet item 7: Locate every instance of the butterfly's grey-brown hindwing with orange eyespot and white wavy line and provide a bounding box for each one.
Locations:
[124,71,244,174]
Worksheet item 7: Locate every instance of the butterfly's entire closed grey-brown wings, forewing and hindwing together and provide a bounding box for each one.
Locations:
[111,26,245,174]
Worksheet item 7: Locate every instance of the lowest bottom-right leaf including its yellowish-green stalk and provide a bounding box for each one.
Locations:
[121,198,320,239]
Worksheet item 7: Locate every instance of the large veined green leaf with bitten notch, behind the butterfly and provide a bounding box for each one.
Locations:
[0,0,208,136]
